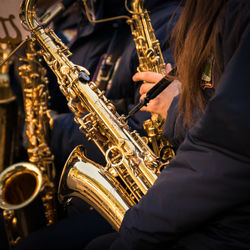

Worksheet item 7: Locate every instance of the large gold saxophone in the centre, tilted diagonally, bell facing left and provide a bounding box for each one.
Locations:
[20,0,162,230]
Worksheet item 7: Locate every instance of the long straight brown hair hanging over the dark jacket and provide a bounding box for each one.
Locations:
[171,0,227,125]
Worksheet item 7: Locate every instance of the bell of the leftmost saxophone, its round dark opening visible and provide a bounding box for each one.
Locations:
[0,162,46,248]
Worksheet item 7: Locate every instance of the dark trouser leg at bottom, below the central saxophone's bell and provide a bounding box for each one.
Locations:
[15,210,113,250]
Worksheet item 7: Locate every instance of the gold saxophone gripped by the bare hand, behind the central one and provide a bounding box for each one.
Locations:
[126,0,175,164]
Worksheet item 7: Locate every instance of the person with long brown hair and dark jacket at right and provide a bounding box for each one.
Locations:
[85,0,250,250]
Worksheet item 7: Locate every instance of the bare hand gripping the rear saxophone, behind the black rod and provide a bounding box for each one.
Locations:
[133,64,181,119]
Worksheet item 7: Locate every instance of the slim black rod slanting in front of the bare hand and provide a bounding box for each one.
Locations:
[124,67,176,121]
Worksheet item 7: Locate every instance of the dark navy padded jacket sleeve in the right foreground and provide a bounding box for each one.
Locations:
[111,2,250,249]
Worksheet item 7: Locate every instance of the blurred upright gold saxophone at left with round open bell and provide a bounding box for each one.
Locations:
[0,42,56,249]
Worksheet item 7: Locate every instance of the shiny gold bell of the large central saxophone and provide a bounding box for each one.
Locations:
[58,145,129,231]
